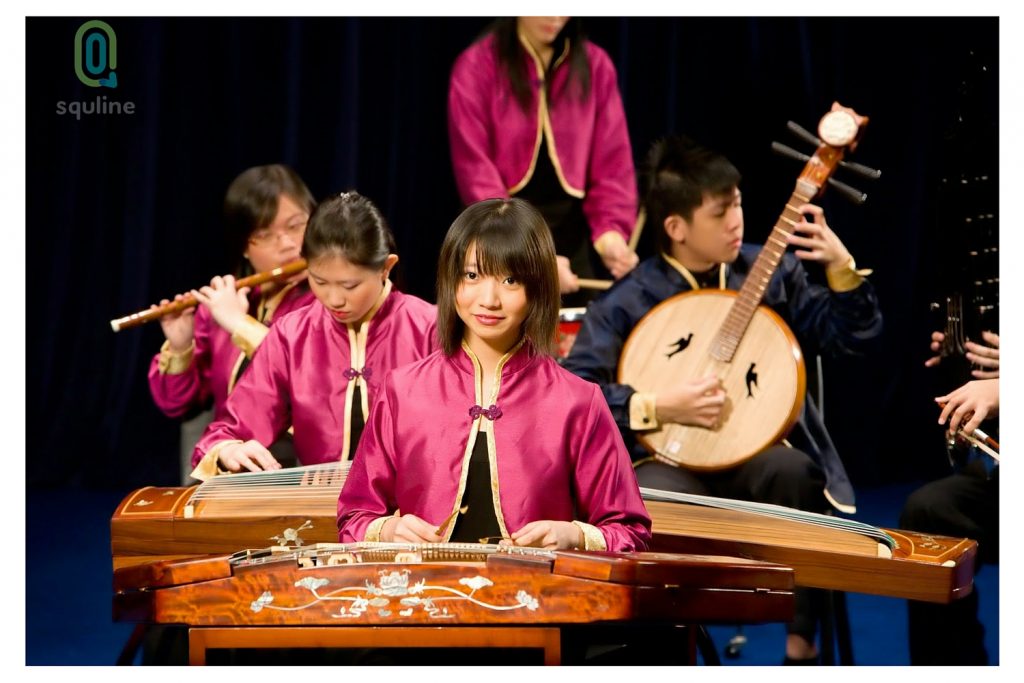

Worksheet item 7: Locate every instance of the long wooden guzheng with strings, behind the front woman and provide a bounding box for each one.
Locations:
[111,464,977,602]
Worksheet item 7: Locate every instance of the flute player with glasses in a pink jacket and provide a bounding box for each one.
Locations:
[150,164,315,447]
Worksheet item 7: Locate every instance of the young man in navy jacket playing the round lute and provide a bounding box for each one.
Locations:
[565,137,882,664]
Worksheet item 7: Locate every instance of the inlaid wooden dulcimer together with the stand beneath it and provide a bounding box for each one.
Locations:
[114,544,794,665]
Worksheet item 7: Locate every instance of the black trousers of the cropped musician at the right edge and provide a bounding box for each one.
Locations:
[899,461,999,665]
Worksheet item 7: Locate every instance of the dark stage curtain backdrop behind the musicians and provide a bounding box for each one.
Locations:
[26,16,998,493]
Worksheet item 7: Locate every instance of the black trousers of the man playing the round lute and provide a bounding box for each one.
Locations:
[636,445,828,642]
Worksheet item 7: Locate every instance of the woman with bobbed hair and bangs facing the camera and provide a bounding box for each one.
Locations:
[338,199,650,551]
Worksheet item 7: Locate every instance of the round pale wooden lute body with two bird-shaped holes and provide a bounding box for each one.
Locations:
[618,290,807,471]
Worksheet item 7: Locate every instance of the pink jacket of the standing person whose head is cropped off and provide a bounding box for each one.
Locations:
[449,36,637,242]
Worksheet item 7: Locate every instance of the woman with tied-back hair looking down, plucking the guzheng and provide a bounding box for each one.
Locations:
[193,193,437,479]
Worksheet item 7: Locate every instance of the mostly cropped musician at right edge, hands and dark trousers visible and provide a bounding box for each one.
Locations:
[899,332,999,666]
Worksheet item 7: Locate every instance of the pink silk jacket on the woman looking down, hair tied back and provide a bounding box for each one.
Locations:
[193,290,437,466]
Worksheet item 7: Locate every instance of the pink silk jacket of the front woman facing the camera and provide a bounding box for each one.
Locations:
[338,343,650,551]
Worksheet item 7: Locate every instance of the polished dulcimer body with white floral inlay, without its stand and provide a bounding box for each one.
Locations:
[114,544,793,627]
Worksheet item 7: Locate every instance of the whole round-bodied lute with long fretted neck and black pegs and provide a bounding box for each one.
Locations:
[618,102,881,470]
